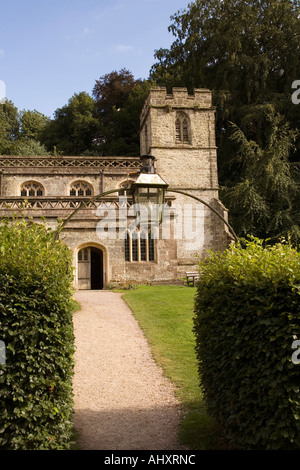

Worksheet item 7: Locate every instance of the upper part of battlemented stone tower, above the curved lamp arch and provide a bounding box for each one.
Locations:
[140,88,218,191]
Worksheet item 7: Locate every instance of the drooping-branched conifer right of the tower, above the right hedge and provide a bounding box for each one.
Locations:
[221,104,300,242]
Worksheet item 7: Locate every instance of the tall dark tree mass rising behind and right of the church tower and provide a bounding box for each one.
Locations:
[150,0,300,241]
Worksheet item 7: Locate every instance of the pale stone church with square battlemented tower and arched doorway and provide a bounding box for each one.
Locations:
[0,88,231,289]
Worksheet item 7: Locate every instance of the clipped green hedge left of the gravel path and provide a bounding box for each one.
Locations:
[0,219,74,450]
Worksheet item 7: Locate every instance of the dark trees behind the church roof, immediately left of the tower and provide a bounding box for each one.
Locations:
[38,69,151,156]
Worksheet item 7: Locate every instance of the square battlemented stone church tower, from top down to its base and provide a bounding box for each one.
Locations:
[140,88,229,273]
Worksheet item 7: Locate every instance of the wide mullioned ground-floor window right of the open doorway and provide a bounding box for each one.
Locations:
[125,231,155,262]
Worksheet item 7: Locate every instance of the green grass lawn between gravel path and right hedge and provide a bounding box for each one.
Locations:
[118,286,223,450]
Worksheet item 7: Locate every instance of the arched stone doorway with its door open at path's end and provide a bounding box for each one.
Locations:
[77,246,104,290]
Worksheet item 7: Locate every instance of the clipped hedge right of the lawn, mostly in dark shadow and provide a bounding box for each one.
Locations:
[194,239,300,450]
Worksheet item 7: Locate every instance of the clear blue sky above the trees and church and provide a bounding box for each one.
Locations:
[0,0,190,117]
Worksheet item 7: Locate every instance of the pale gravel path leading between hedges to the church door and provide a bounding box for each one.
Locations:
[73,291,181,450]
